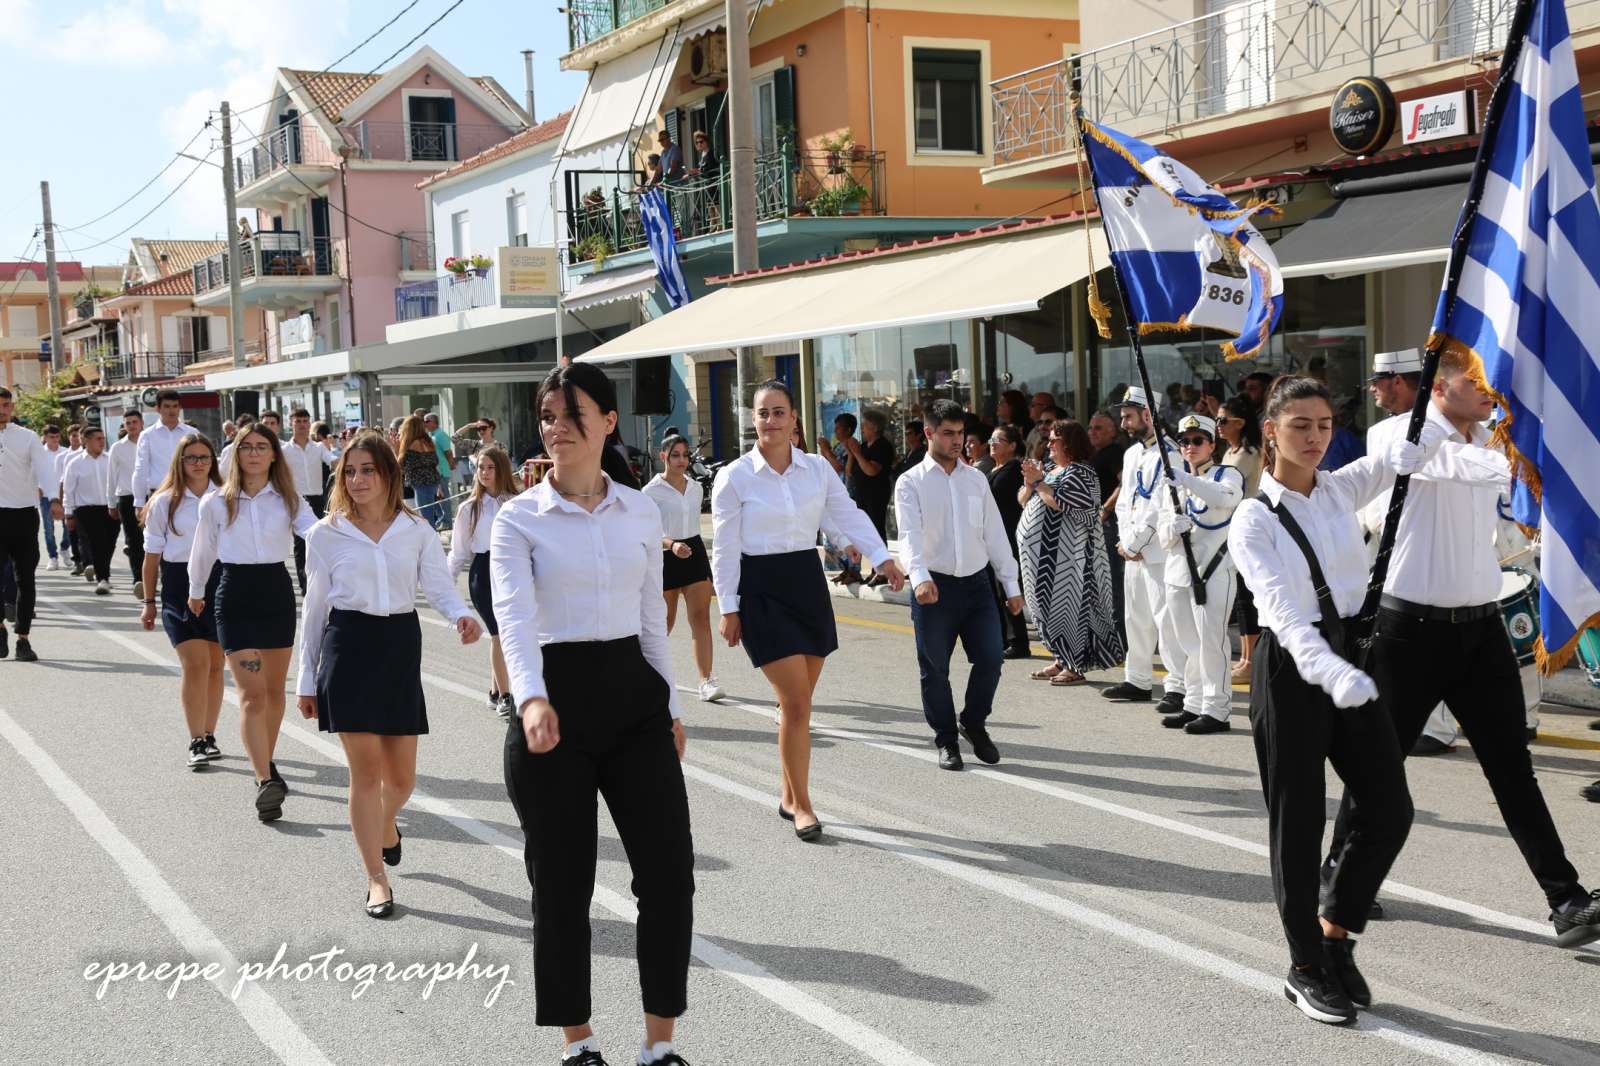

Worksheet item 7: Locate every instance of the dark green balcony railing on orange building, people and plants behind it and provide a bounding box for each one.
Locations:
[563,149,886,262]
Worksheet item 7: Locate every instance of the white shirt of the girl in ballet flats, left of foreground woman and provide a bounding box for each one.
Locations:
[294,507,472,696]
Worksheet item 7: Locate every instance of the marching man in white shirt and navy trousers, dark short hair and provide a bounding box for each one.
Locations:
[894,400,1022,770]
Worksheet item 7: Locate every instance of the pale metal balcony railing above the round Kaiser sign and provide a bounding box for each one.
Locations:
[990,0,1523,163]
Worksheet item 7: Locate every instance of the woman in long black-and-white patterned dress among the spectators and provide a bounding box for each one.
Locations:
[1016,419,1123,685]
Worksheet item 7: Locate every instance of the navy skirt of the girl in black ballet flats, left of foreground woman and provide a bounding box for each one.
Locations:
[317,608,427,736]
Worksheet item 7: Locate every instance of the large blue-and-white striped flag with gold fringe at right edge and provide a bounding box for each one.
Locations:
[1432,0,1600,671]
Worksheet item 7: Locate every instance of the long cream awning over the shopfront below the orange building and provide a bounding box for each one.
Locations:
[578,222,1109,363]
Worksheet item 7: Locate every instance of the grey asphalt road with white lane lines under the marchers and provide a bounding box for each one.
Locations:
[0,560,1600,1066]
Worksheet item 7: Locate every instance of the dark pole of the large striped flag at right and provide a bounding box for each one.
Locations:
[1357,0,1534,651]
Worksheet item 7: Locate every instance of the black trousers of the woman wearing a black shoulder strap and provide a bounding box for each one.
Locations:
[1250,629,1413,967]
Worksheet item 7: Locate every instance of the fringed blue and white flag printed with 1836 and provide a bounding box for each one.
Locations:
[1083,122,1283,359]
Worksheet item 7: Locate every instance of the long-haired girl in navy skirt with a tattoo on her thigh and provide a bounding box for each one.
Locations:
[189,423,317,821]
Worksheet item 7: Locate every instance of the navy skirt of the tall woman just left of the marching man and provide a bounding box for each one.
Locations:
[739,547,838,667]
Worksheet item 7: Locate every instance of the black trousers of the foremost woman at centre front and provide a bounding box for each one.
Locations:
[506,637,694,1026]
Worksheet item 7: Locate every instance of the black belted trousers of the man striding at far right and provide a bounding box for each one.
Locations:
[1333,608,1587,908]
